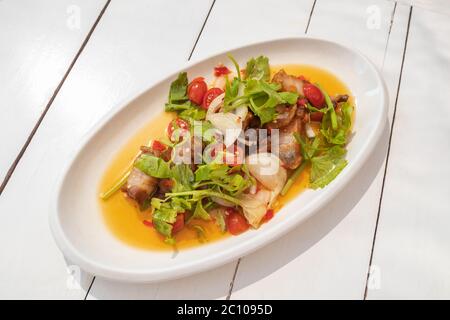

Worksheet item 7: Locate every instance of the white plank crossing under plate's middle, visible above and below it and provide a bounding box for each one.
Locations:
[88,0,313,299]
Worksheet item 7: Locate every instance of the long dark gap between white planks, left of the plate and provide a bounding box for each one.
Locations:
[0,0,111,196]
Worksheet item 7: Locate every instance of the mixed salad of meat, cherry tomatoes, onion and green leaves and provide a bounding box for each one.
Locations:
[100,55,354,245]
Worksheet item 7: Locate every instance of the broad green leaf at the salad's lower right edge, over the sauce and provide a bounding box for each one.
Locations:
[310,146,347,189]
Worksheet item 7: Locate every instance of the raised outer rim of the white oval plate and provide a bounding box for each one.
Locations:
[49,36,389,283]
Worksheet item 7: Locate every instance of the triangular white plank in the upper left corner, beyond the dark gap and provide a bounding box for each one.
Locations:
[0,0,106,184]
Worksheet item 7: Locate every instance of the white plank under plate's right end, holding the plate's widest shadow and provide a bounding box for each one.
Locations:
[231,0,409,299]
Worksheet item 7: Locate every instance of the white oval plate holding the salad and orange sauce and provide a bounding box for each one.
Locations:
[50,38,388,282]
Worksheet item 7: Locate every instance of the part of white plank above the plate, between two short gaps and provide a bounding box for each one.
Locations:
[192,0,314,59]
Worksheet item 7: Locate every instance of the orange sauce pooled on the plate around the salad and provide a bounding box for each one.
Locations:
[99,65,353,250]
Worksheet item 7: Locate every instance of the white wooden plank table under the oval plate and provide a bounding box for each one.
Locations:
[0,0,450,299]
